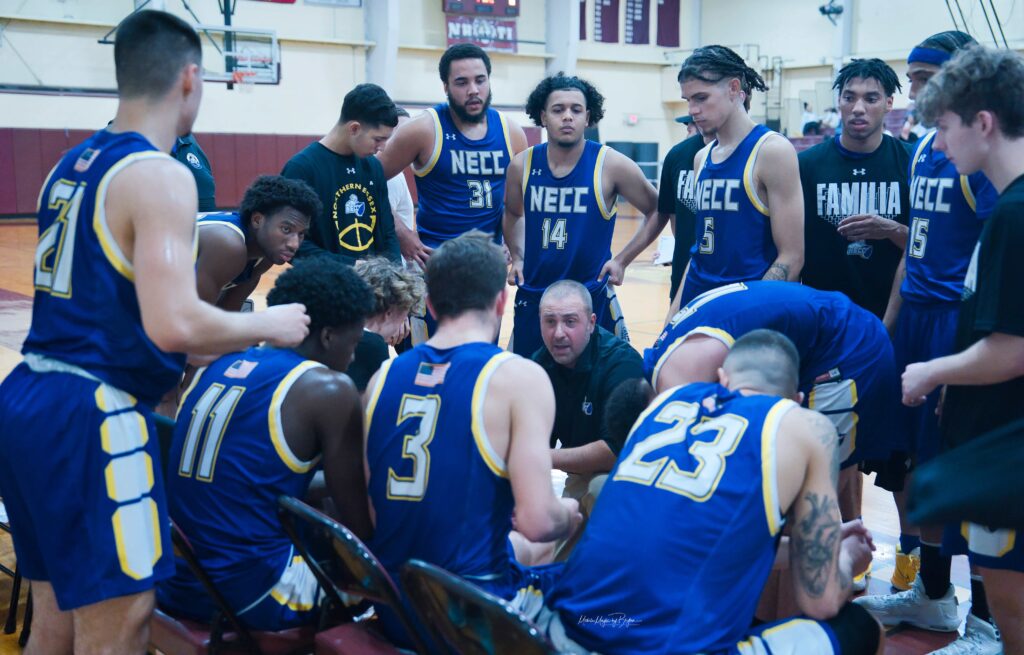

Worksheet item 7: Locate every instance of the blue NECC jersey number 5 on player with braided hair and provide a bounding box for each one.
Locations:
[686,125,778,290]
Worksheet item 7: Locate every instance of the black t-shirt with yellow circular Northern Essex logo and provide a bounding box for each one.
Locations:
[281,141,401,263]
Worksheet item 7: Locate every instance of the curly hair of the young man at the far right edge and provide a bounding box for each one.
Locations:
[915,45,1024,138]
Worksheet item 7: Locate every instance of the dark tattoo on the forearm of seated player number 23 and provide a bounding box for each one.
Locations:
[792,491,840,598]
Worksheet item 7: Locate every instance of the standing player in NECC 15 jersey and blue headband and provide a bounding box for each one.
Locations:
[861,32,1001,655]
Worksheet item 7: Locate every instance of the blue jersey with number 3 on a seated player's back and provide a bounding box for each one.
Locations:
[367,343,515,598]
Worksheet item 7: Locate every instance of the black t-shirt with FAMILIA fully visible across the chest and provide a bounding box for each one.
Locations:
[799,135,912,318]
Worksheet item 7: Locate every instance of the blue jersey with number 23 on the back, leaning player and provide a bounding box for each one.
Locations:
[548,383,797,654]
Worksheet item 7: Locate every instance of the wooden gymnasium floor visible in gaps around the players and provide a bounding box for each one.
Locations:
[0,210,970,655]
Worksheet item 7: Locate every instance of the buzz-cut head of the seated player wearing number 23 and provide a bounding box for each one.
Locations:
[719,330,800,398]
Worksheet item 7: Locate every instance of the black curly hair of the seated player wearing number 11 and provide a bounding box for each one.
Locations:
[266,257,377,334]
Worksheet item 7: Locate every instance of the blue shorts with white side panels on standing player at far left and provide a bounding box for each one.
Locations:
[0,353,173,611]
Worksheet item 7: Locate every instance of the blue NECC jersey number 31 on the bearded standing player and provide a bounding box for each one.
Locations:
[413,102,512,248]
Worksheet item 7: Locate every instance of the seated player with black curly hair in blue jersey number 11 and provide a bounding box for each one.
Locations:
[157,257,375,630]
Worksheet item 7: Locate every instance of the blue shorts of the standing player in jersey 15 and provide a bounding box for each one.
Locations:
[893,301,959,466]
